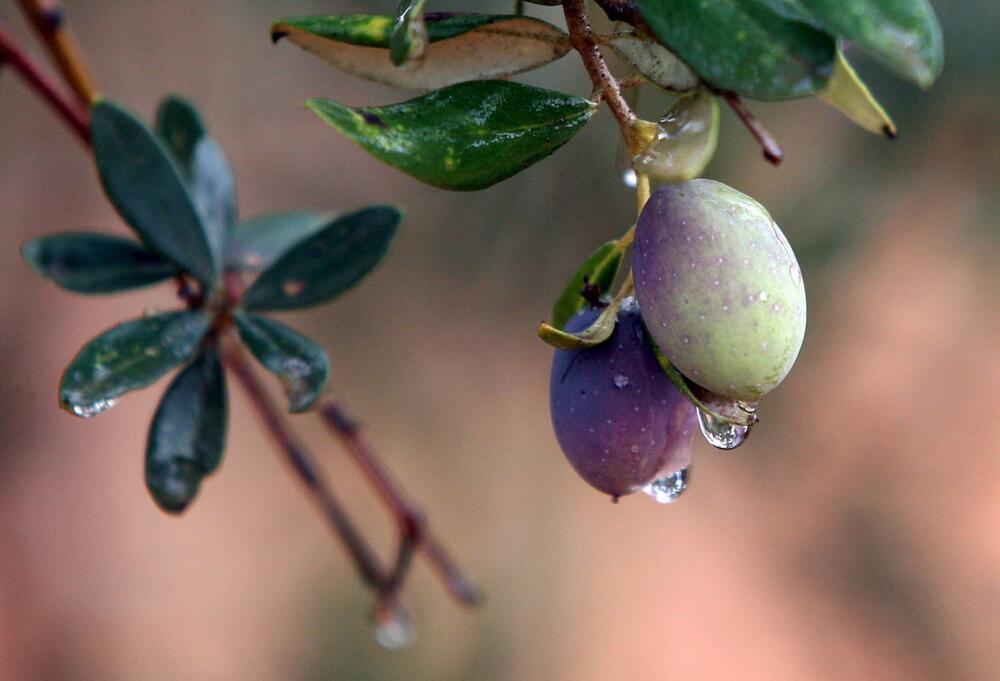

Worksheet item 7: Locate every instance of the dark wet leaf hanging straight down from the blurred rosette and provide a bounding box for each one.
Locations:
[146,347,228,513]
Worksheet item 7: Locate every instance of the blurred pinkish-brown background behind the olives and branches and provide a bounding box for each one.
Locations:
[0,0,1000,681]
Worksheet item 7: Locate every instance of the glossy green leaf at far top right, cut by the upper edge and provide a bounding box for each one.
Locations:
[799,0,944,87]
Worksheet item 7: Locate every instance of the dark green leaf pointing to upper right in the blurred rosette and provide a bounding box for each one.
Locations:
[243,206,402,310]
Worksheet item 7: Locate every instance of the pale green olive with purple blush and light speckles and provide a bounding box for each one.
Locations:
[632,180,806,402]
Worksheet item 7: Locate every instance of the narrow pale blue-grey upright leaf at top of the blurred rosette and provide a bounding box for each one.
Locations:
[190,137,236,261]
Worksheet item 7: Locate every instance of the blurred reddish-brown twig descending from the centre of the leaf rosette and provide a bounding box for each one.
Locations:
[226,343,389,594]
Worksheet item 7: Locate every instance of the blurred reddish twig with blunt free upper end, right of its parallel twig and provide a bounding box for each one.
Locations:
[319,400,482,605]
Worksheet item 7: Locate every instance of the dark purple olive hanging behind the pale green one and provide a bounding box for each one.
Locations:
[549,299,698,499]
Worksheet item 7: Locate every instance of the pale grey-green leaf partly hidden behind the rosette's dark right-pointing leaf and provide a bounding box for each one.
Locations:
[226,211,336,272]
